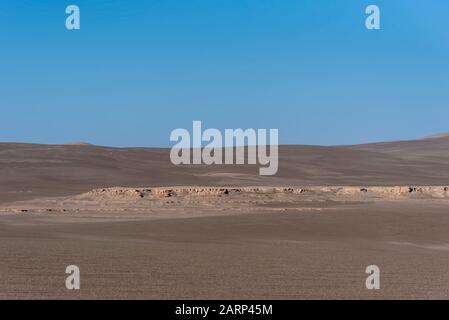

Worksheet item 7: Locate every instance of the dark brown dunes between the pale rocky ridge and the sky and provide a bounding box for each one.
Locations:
[0,137,449,203]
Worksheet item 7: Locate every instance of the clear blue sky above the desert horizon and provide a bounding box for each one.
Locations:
[0,0,449,146]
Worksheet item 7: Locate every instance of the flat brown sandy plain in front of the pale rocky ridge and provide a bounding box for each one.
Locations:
[0,200,449,299]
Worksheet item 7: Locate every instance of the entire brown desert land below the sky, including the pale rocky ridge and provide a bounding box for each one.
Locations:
[0,138,449,299]
